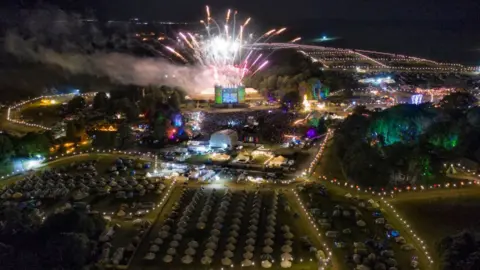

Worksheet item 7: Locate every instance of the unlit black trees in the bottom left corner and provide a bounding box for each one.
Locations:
[0,208,106,270]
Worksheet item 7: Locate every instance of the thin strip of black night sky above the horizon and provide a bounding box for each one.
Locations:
[0,0,480,23]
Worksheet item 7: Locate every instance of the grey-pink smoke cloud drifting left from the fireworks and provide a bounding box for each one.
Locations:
[5,8,214,95]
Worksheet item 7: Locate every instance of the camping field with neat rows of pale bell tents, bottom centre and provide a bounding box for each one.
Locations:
[132,186,321,269]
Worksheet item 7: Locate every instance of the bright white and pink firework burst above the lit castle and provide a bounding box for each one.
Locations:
[166,6,292,85]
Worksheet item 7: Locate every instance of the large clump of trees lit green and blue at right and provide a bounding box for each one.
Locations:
[333,92,480,187]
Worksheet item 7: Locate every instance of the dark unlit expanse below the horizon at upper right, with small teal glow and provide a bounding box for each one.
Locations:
[291,20,480,65]
